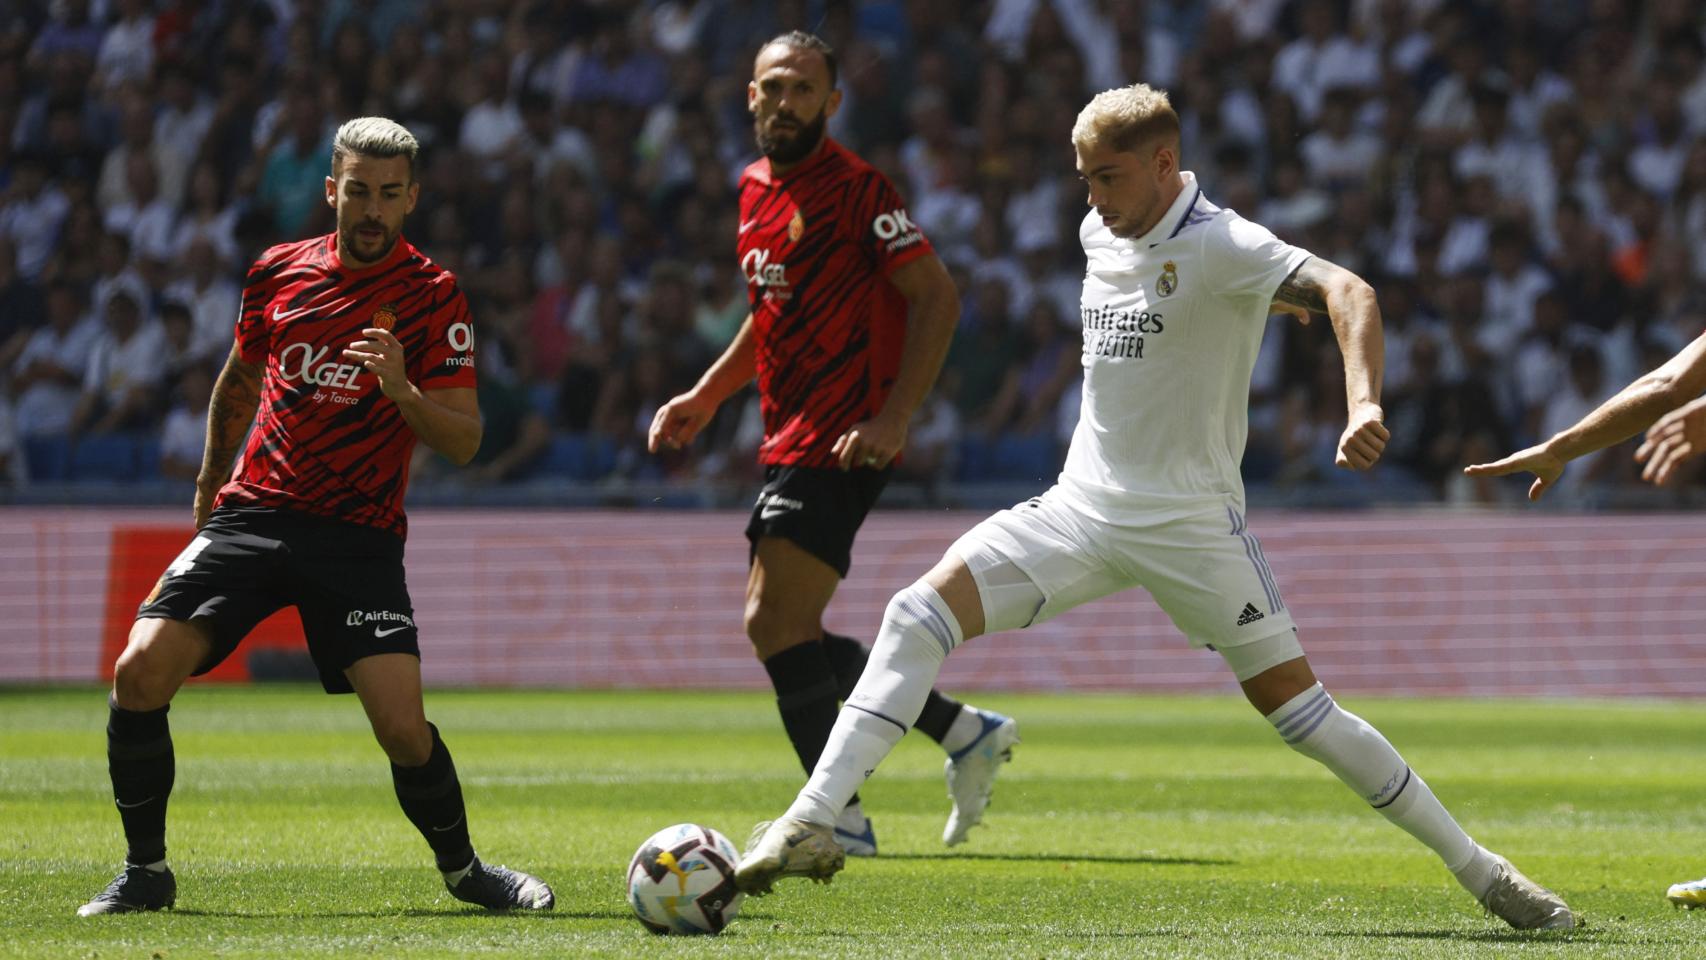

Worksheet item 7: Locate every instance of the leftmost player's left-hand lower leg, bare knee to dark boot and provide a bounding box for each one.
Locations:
[77,617,213,917]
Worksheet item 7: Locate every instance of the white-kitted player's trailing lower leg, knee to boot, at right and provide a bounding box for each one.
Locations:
[1221,651,1575,929]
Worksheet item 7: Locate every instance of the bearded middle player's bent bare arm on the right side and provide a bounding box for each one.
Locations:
[833,254,959,471]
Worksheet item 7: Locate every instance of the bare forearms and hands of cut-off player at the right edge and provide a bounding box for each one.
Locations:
[1464,334,1706,500]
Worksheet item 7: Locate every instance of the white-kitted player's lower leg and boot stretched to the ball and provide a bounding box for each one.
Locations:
[735,552,1012,893]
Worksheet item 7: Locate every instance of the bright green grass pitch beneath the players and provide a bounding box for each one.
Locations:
[0,687,1706,960]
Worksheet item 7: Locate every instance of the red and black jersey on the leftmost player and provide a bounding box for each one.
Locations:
[217,234,474,537]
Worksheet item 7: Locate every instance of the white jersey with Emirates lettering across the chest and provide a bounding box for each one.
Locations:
[1059,172,1310,523]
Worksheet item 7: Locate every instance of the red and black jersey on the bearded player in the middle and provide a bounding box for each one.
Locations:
[737,138,933,467]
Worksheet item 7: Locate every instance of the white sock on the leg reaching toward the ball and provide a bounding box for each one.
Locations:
[785,581,966,825]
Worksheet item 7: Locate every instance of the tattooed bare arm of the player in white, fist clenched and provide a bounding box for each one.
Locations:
[1274,256,1392,471]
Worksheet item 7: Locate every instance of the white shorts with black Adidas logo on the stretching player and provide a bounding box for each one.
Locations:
[949,488,1302,654]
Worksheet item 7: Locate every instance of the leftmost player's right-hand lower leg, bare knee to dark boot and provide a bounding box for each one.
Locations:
[345,653,554,911]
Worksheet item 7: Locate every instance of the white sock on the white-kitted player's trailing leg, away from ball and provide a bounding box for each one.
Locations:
[1268,684,1486,897]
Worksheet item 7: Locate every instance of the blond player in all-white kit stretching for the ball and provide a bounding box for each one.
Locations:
[735,84,1575,929]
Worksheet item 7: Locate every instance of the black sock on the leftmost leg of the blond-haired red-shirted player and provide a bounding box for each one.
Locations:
[107,696,176,866]
